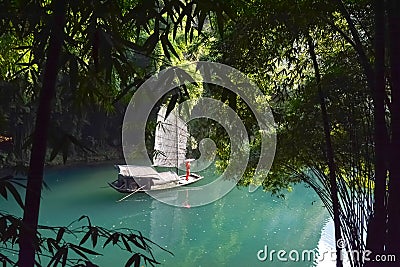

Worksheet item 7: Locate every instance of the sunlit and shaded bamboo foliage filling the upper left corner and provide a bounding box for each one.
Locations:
[0,0,233,164]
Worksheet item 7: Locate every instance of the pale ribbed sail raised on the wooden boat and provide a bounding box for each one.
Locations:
[153,107,188,167]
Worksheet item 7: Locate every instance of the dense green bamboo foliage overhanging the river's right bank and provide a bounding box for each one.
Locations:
[208,0,380,266]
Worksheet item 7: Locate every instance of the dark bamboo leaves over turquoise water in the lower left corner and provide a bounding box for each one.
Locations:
[0,176,172,266]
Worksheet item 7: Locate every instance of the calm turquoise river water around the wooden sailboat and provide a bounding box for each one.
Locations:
[0,165,328,267]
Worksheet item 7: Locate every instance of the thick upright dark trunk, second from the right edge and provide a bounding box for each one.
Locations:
[366,0,388,266]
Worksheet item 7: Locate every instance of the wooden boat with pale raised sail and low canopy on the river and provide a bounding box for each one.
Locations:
[109,107,203,193]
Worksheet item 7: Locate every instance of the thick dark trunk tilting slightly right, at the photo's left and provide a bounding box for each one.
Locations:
[18,0,66,267]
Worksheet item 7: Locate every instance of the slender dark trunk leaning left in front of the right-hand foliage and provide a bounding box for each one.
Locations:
[307,34,343,267]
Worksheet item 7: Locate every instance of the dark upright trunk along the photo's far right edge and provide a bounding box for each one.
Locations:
[387,0,400,260]
